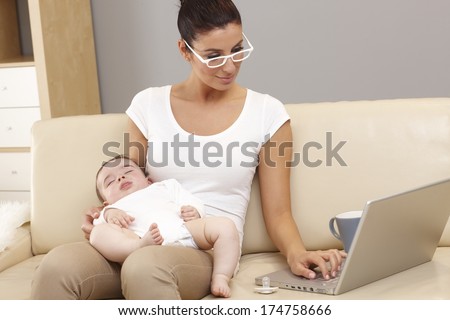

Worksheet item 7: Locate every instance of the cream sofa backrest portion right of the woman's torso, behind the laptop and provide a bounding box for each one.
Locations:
[243,98,450,253]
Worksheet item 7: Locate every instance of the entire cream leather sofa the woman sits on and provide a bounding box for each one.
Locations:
[0,98,450,300]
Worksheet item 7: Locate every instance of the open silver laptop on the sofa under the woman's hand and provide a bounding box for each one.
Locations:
[255,179,450,295]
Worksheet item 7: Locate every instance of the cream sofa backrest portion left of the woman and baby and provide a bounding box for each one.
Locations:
[31,114,127,254]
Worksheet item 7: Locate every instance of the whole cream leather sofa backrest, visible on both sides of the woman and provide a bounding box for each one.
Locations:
[31,98,450,254]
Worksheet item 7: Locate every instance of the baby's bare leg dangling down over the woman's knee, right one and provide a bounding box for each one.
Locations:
[186,217,240,298]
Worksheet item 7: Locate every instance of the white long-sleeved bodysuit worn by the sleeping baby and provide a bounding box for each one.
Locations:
[94,179,205,245]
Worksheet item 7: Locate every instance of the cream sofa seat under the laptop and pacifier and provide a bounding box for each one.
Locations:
[205,247,450,300]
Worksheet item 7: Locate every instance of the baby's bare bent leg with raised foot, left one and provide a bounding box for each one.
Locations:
[89,223,163,263]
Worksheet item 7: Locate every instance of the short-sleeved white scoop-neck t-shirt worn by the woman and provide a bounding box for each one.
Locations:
[126,85,289,241]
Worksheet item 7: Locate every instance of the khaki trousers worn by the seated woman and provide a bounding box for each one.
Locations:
[31,242,213,300]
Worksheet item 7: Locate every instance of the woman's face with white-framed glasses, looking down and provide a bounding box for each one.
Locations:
[186,23,244,90]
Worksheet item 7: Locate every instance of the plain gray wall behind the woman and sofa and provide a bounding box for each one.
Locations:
[91,0,450,113]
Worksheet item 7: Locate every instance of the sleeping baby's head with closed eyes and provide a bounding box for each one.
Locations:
[96,155,151,204]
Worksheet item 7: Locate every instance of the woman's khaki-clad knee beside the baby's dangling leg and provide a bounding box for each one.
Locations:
[122,246,212,300]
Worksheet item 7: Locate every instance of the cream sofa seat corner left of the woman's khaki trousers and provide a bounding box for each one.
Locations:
[0,255,44,300]
